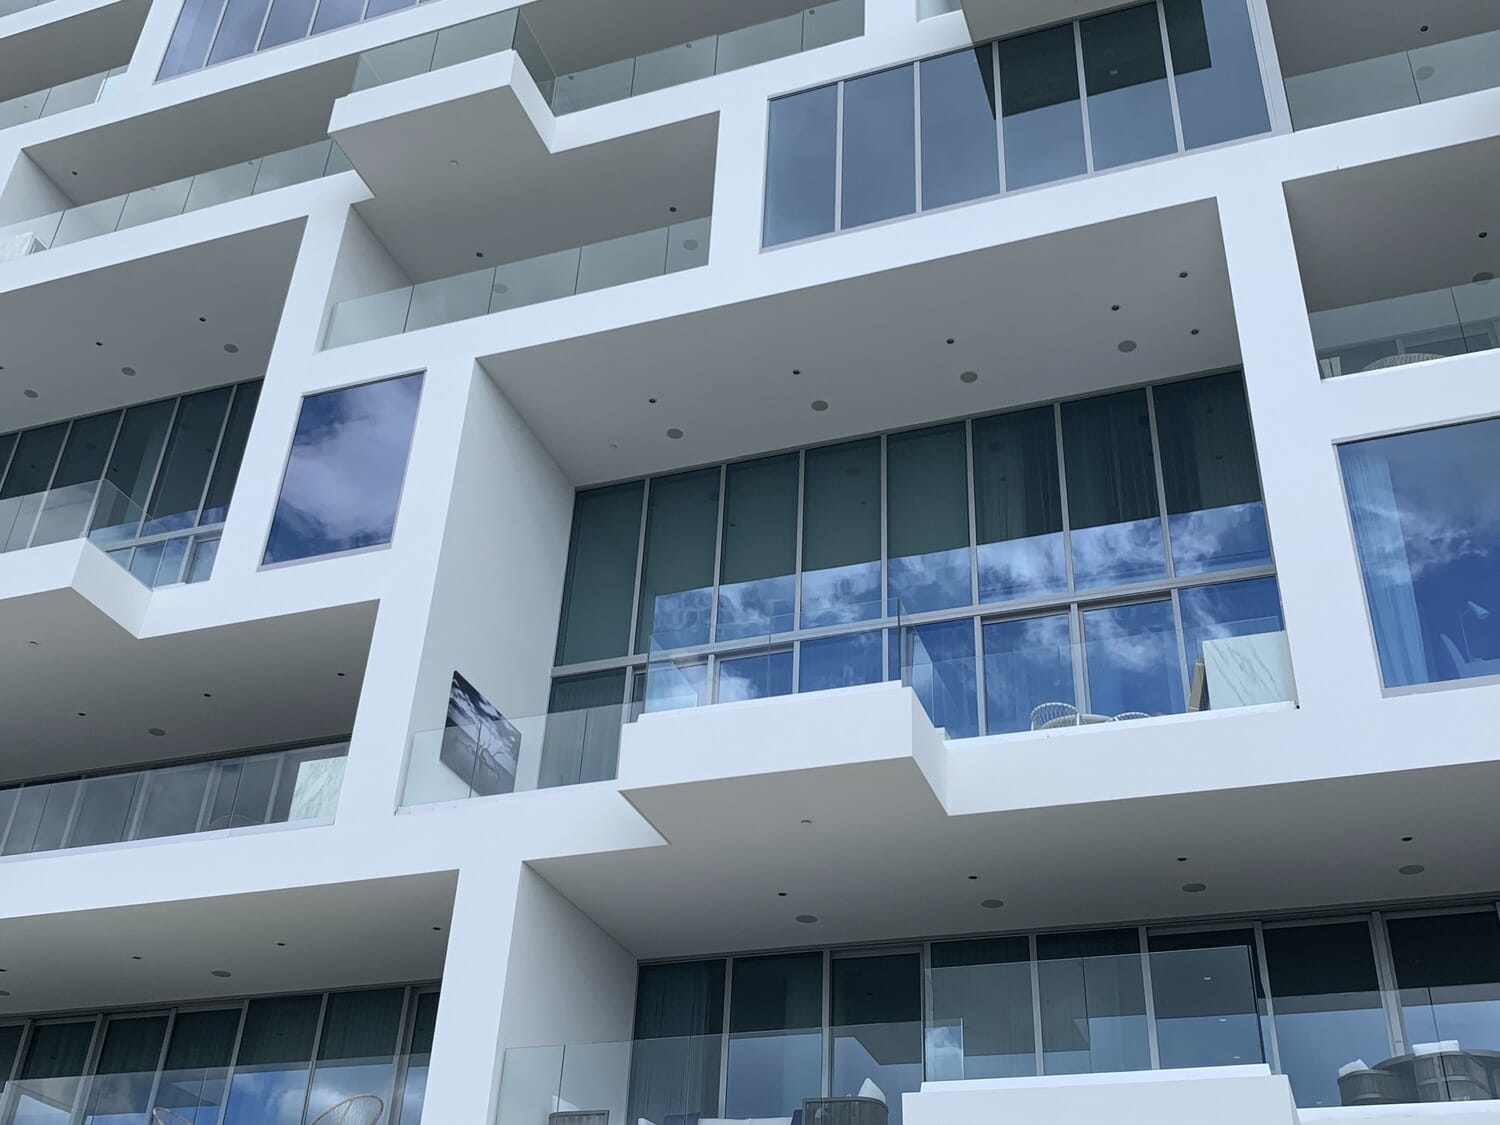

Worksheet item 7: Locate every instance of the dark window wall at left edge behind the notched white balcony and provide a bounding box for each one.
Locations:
[0,380,261,587]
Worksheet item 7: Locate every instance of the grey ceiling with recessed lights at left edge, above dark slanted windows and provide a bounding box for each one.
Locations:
[0,222,302,432]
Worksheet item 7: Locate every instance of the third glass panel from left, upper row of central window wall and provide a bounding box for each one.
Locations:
[717,453,798,641]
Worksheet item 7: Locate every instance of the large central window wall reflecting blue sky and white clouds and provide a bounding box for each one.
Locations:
[558,372,1292,741]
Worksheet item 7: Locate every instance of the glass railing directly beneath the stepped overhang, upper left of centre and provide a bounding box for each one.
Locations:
[323,218,711,348]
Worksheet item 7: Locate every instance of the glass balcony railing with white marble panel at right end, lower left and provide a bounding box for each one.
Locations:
[0,743,348,855]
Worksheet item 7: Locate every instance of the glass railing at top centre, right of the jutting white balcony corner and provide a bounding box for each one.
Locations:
[546,0,864,114]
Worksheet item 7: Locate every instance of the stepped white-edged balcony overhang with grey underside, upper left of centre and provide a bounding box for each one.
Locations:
[329,51,719,282]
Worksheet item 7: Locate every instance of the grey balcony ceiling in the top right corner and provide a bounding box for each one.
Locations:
[1269,0,1500,78]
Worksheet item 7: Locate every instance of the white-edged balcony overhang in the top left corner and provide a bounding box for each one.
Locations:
[0,0,152,102]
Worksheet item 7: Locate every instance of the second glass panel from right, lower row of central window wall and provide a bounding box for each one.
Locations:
[1083,600,1184,717]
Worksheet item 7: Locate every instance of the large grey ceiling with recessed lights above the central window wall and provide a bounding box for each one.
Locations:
[485,201,1239,483]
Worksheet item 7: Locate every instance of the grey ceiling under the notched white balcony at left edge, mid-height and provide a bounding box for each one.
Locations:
[0,594,375,783]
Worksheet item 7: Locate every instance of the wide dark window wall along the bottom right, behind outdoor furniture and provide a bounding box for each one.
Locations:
[632,903,1500,1121]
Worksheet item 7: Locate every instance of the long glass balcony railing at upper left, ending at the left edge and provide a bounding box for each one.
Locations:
[0,140,350,261]
